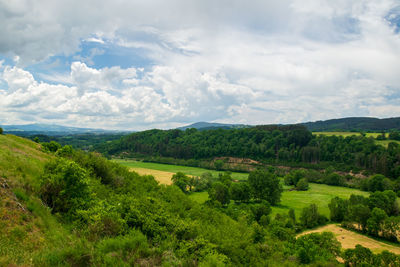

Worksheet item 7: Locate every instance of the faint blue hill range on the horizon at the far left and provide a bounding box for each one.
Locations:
[0,123,125,136]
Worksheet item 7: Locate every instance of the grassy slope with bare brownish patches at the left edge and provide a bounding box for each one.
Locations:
[0,135,76,266]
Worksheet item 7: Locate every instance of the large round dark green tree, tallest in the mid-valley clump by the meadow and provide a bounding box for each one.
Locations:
[248,169,283,205]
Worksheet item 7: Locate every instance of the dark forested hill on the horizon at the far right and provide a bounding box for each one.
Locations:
[300,117,400,132]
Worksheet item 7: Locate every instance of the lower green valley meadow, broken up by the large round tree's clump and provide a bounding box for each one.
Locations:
[189,183,369,218]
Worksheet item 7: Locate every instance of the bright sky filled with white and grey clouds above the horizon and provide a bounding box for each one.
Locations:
[0,0,400,130]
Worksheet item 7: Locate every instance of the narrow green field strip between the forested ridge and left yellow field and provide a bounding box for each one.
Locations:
[113,159,249,180]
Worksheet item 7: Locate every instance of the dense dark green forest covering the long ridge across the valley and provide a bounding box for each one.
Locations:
[95,125,400,178]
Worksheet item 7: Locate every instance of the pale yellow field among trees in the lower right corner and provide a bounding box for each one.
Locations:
[299,224,400,254]
